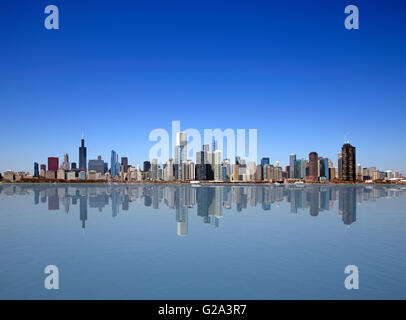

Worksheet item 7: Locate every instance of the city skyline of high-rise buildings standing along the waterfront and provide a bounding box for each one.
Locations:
[3,132,406,183]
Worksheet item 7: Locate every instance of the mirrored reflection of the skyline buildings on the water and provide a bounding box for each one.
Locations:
[0,184,406,236]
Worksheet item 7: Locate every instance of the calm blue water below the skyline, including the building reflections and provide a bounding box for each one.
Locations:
[0,184,406,299]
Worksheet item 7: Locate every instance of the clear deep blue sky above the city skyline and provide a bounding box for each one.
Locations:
[0,0,406,174]
